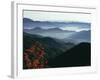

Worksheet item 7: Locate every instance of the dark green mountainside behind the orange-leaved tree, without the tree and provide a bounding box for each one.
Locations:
[23,32,74,59]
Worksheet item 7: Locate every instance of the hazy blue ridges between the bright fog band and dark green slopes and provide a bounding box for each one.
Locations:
[24,27,91,43]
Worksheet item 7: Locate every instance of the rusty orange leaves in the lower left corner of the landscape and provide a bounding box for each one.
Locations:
[23,44,48,69]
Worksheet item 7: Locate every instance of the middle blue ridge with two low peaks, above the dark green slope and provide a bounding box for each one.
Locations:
[24,27,75,39]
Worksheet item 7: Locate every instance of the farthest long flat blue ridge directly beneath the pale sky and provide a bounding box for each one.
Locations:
[23,18,91,29]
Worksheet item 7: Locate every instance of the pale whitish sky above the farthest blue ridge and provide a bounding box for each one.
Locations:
[23,11,91,23]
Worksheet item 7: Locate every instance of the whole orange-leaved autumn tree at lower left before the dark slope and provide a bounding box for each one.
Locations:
[23,42,48,69]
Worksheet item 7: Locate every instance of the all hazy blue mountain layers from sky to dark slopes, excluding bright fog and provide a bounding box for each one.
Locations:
[23,18,91,43]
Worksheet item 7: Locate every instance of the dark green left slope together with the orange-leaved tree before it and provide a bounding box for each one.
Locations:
[23,33,74,69]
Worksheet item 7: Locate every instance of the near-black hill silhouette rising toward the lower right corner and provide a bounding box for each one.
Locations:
[49,43,91,67]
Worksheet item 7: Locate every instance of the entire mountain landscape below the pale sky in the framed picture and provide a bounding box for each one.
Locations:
[23,18,91,69]
